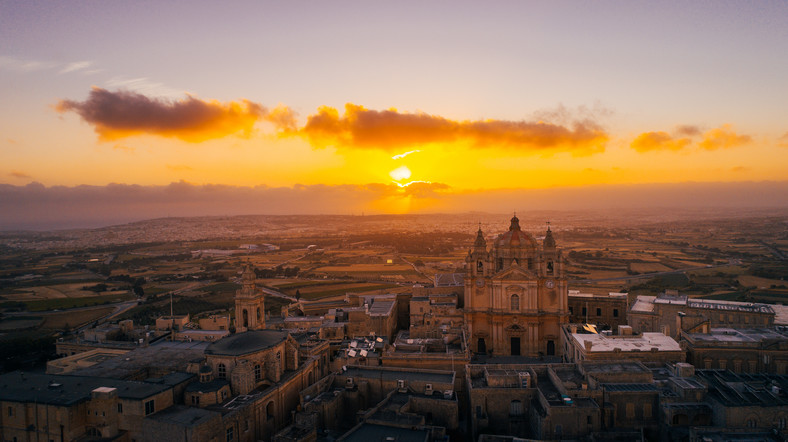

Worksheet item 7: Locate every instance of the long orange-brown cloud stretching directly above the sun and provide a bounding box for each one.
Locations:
[291,103,609,154]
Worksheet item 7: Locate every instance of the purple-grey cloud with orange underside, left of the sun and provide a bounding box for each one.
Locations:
[55,87,292,143]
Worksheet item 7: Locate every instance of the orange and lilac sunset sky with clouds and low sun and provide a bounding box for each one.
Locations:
[0,0,788,228]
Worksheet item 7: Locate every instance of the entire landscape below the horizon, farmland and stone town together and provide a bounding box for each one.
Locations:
[0,209,788,442]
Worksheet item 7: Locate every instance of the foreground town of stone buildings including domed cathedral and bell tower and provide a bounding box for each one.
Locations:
[0,216,788,442]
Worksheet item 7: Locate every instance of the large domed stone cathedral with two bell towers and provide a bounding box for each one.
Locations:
[463,215,569,357]
